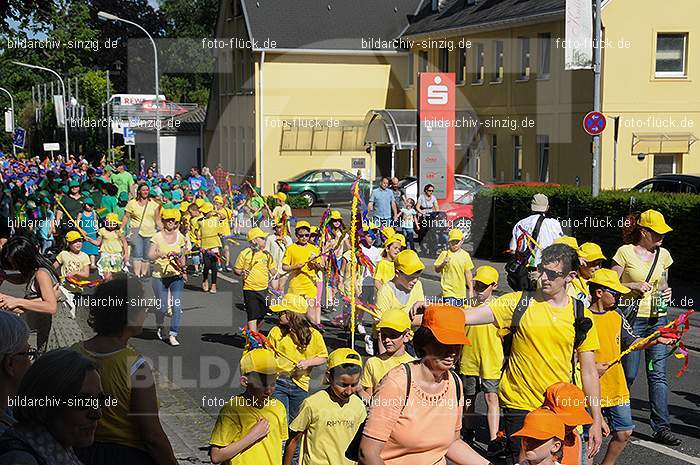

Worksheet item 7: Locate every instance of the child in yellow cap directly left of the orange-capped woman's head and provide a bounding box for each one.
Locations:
[359,309,414,402]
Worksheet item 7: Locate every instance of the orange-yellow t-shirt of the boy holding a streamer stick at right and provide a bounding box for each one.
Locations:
[593,311,630,407]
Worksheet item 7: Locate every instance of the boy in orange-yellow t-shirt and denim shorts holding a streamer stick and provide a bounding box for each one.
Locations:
[588,268,675,464]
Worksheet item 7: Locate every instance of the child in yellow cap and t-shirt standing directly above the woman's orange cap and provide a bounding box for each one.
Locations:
[435,229,474,307]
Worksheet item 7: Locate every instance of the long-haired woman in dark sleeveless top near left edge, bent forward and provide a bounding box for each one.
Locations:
[0,236,83,352]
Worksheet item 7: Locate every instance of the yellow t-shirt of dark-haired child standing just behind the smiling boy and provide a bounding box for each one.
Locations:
[267,326,328,392]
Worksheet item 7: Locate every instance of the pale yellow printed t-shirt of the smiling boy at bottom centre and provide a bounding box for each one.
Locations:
[289,390,367,465]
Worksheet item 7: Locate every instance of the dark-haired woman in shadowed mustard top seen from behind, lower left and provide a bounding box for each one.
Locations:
[73,278,177,465]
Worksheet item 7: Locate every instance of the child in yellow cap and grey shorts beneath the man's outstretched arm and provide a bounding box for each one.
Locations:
[459,266,506,457]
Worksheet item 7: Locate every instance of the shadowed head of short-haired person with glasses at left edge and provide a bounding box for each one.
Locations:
[0,311,37,435]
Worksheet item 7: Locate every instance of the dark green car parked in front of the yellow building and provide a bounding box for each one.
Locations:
[277,169,369,206]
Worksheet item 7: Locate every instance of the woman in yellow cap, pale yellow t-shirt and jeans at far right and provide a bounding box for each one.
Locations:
[612,210,681,446]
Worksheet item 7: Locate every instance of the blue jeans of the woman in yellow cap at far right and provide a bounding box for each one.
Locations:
[622,316,671,432]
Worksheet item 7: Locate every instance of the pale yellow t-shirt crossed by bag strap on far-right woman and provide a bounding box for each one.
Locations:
[613,244,673,318]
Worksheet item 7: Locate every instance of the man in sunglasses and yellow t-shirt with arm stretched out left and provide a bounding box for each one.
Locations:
[464,244,602,463]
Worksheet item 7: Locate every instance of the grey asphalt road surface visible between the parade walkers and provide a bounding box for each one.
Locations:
[2,237,700,465]
